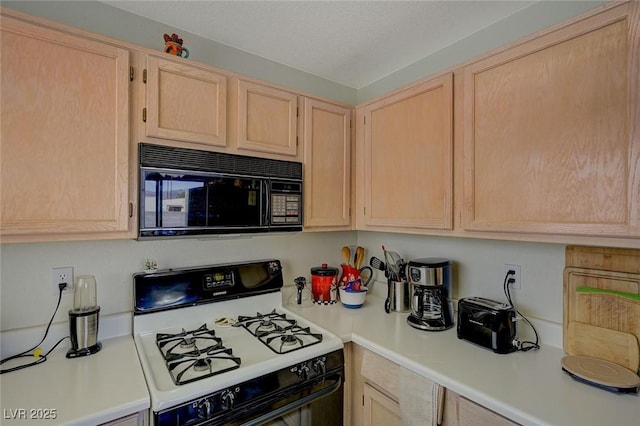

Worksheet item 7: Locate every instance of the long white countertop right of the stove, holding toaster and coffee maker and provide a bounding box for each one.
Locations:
[286,295,640,426]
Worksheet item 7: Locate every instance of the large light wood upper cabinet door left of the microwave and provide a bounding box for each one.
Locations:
[0,15,129,242]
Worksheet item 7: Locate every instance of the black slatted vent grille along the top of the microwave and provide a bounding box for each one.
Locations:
[140,143,302,179]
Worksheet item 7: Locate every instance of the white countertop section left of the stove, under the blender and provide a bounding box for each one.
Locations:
[0,336,150,425]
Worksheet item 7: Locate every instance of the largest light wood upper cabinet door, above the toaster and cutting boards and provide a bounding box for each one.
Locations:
[464,2,640,236]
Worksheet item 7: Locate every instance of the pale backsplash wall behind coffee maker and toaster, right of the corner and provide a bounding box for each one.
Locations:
[358,231,565,348]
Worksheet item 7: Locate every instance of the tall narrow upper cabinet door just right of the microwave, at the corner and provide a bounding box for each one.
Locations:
[303,98,351,227]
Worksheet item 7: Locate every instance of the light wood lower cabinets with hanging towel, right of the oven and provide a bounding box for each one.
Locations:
[344,343,517,426]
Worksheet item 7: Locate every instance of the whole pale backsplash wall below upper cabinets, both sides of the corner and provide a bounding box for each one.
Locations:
[0,231,565,356]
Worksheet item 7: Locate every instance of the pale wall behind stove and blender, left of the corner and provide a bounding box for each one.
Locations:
[0,232,356,331]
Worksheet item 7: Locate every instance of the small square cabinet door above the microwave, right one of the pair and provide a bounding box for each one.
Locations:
[237,80,298,156]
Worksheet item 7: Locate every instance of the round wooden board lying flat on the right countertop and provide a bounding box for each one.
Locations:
[560,355,640,393]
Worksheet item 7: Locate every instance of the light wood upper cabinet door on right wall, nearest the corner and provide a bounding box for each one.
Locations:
[364,74,453,229]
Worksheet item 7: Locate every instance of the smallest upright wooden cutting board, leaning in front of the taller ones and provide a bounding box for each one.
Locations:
[566,321,640,371]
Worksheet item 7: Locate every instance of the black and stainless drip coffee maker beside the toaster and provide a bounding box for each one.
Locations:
[407,258,454,331]
